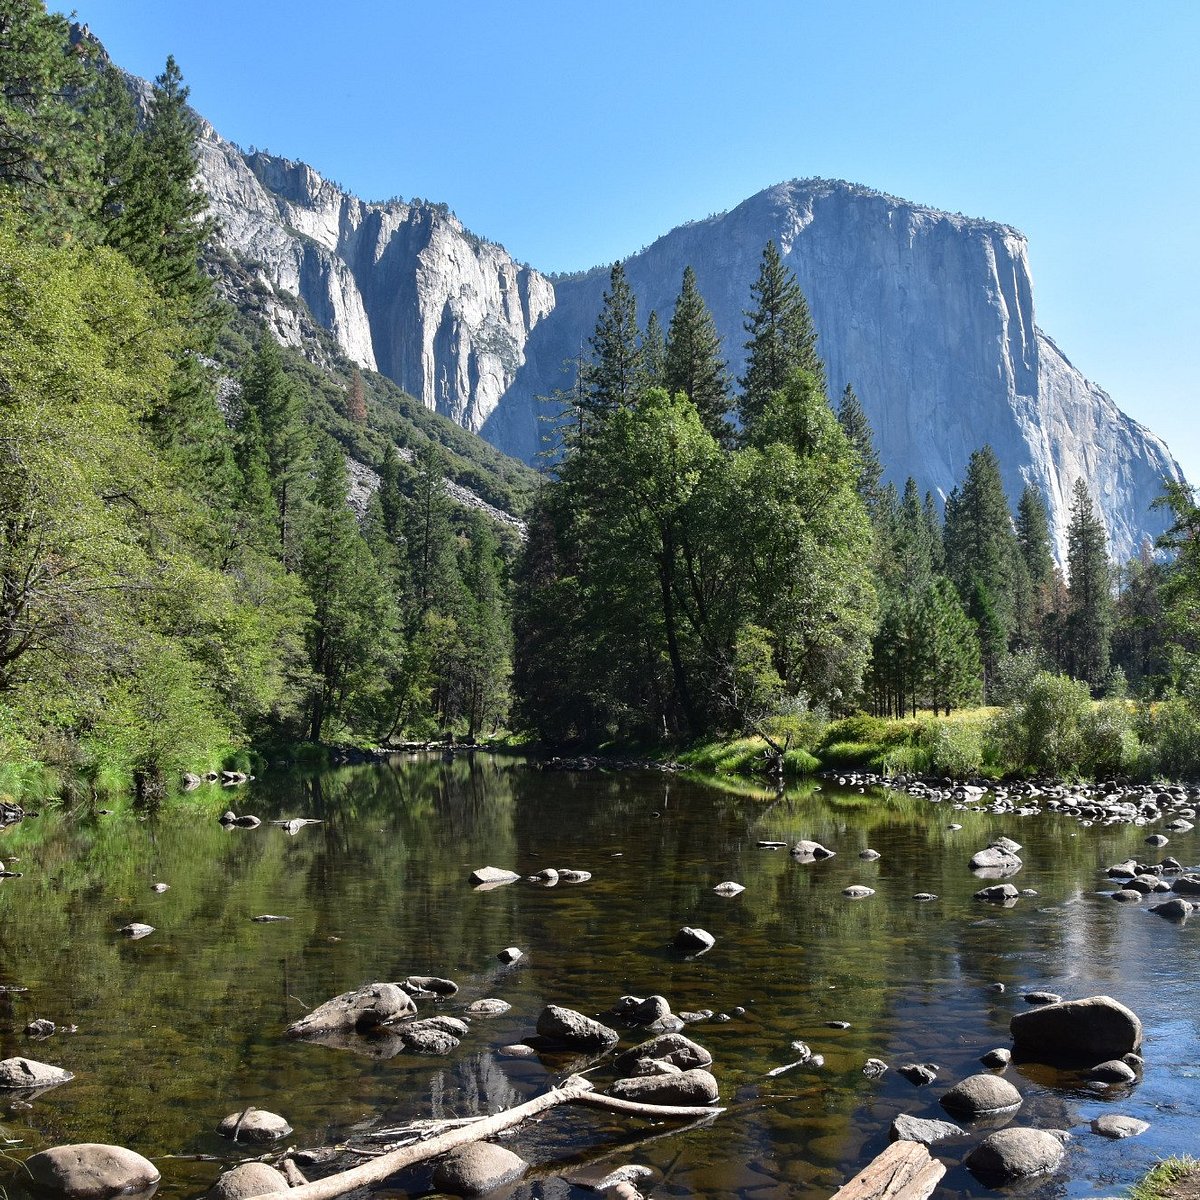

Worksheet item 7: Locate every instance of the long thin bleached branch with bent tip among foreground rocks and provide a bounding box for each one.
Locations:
[256,1076,720,1200]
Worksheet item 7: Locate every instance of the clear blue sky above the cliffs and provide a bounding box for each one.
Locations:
[68,0,1200,481]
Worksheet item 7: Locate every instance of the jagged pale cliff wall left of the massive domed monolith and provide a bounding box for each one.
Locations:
[200,126,554,430]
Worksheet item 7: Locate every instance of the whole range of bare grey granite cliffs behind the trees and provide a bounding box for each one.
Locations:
[202,130,1181,559]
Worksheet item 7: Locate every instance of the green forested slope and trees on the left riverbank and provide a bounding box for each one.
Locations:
[0,9,516,794]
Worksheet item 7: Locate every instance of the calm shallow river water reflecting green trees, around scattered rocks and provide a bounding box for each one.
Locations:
[0,756,1200,1200]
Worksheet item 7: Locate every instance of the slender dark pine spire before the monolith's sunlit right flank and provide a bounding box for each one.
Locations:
[1067,479,1112,691]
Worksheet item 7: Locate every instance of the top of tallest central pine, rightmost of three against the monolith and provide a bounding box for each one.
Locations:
[738,241,824,430]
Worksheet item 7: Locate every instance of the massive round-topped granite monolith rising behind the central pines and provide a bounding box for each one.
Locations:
[482,180,1182,558]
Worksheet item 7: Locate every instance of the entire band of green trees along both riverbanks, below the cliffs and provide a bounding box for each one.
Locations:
[7,0,1200,794]
